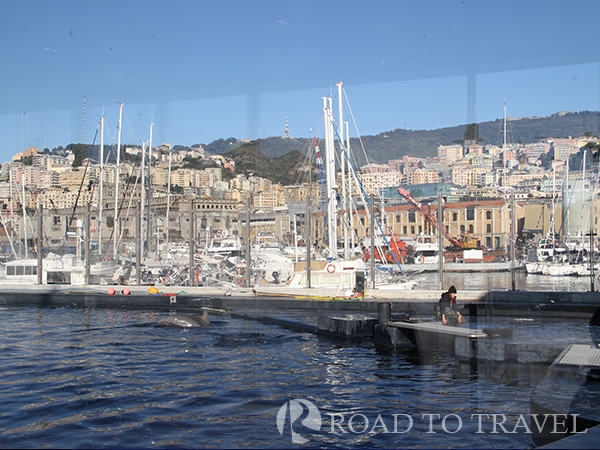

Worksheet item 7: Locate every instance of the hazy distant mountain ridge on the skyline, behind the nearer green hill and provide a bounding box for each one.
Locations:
[224,111,600,171]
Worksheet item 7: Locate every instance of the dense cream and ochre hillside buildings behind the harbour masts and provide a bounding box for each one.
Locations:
[0,132,598,256]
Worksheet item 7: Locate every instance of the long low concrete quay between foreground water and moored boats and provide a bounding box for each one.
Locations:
[0,285,600,320]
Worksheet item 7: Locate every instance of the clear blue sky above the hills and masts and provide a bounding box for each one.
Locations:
[0,0,600,162]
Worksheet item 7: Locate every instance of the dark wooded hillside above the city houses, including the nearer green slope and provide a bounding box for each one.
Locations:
[48,111,600,185]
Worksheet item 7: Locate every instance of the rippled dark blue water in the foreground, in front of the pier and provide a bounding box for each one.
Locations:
[0,307,589,448]
